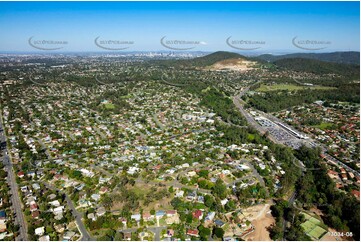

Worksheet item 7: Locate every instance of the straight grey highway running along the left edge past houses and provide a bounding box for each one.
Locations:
[0,114,28,241]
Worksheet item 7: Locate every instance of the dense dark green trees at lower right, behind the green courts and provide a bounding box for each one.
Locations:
[296,147,360,240]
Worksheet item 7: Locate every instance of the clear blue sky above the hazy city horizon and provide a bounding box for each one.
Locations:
[0,2,360,53]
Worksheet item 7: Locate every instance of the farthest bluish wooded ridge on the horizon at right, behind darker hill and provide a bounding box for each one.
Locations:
[254,51,360,65]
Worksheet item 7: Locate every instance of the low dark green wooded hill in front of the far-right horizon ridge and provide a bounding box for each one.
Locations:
[273,58,360,76]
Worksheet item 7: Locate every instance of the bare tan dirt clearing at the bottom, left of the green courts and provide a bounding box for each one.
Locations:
[243,204,275,241]
